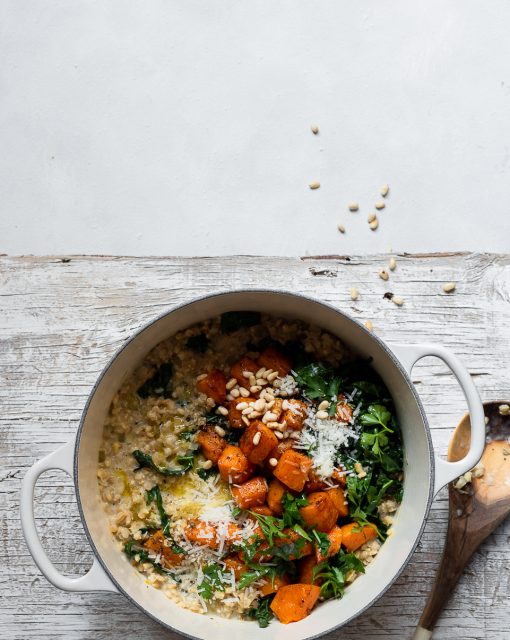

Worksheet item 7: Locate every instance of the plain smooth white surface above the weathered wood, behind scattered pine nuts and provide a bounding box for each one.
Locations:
[0,0,510,255]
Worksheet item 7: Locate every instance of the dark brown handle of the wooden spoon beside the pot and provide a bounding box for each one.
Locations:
[413,485,481,640]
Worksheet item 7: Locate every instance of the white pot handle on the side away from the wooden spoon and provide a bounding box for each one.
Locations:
[20,439,118,593]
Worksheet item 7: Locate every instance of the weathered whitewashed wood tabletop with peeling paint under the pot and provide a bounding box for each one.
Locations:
[0,254,510,640]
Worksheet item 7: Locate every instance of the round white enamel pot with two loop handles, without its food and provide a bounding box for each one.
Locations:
[21,290,485,640]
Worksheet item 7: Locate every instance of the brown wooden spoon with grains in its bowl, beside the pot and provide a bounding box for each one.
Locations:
[413,402,510,640]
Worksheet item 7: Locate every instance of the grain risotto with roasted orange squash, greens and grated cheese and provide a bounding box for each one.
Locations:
[97,312,403,627]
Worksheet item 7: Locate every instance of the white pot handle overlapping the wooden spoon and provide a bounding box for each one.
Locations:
[391,344,485,495]
